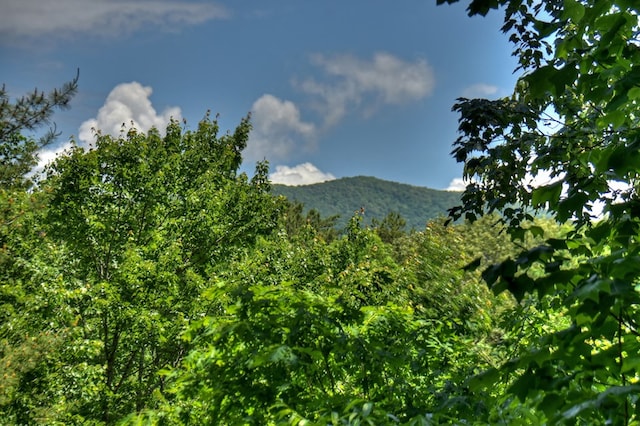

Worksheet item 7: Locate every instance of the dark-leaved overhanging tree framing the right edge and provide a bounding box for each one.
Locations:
[438,0,640,424]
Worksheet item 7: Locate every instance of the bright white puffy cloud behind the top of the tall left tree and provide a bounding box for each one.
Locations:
[78,81,182,145]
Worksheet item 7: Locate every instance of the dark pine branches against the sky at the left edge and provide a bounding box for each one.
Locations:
[0,72,80,188]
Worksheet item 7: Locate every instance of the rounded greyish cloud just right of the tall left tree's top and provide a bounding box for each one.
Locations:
[243,94,316,161]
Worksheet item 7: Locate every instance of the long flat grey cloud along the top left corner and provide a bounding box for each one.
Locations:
[0,0,228,45]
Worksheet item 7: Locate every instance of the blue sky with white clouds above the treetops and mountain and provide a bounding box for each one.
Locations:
[0,0,516,189]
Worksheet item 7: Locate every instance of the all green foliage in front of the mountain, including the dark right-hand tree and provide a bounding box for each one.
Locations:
[0,0,640,425]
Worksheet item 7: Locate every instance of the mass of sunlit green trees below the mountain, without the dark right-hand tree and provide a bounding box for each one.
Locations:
[0,104,544,424]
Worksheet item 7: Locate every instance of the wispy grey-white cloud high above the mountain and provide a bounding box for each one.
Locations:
[297,52,435,126]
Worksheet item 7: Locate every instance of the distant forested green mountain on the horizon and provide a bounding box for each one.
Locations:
[273,176,461,229]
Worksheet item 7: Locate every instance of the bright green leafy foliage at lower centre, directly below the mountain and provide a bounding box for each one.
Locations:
[140,215,504,424]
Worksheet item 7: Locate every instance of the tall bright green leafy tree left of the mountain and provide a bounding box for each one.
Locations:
[15,116,278,424]
